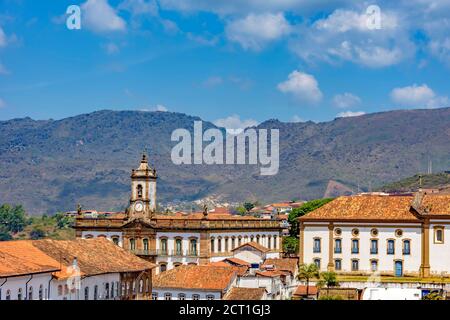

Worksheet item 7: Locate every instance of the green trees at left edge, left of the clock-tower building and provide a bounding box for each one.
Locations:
[0,204,75,241]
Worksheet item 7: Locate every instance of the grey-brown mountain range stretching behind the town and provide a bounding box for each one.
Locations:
[0,108,450,214]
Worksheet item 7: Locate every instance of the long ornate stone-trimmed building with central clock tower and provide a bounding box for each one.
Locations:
[75,155,283,272]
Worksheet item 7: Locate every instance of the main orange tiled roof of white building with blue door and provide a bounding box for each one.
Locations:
[299,195,418,221]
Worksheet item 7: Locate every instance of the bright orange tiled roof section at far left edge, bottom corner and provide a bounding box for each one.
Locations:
[0,240,60,277]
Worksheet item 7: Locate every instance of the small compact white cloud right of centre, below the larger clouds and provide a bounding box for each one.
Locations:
[277,70,323,103]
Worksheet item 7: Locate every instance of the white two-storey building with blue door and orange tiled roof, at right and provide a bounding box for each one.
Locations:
[299,191,450,277]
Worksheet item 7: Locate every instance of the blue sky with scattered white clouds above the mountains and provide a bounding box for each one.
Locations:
[0,0,450,128]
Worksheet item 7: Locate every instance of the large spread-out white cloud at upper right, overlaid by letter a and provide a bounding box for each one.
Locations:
[290,9,415,68]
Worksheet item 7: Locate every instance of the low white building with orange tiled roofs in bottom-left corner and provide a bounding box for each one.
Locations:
[0,239,155,300]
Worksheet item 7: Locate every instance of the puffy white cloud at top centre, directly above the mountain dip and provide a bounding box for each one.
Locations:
[225,13,292,51]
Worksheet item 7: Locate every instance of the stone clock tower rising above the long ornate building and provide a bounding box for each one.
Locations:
[127,153,157,220]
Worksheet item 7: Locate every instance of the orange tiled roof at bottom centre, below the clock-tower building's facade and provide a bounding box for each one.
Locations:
[153,265,237,291]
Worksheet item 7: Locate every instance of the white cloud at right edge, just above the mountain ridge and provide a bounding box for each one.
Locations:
[391,84,450,108]
